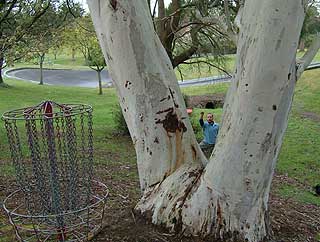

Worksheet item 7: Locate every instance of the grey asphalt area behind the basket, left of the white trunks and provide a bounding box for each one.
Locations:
[6,68,111,87]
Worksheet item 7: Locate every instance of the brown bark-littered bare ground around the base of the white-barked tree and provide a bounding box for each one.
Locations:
[0,165,320,242]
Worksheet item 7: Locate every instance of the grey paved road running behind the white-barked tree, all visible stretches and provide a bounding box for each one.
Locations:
[5,62,320,87]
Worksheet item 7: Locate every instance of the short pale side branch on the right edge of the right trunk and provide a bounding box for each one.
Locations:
[297,33,320,79]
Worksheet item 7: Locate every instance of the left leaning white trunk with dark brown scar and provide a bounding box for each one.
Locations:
[89,0,206,189]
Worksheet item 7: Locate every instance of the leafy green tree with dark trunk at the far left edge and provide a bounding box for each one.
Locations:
[0,0,52,86]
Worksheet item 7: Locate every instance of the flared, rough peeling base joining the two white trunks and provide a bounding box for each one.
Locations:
[135,166,268,242]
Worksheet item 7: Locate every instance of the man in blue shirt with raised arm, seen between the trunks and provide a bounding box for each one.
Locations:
[199,112,219,154]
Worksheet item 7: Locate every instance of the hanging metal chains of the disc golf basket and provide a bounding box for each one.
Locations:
[4,101,93,234]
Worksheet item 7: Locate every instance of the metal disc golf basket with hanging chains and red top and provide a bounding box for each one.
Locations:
[2,101,108,242]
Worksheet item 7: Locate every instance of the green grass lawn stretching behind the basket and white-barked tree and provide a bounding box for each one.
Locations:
[0,70,320,205]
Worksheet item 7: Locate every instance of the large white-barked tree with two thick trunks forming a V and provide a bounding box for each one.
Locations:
[88,0,320,241]
